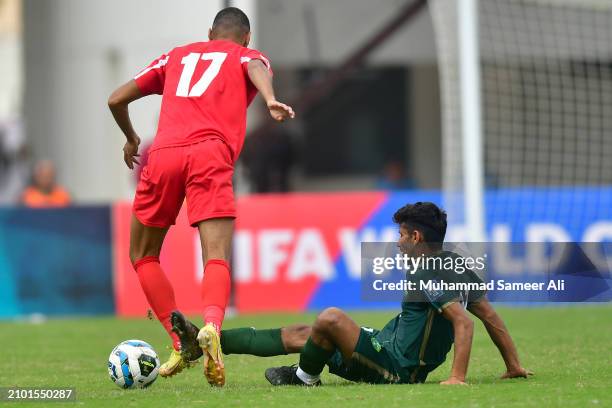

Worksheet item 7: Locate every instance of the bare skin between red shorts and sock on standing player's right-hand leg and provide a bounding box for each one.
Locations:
[198,217,234,262]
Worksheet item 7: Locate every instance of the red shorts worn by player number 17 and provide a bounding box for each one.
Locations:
[133,139,236,228]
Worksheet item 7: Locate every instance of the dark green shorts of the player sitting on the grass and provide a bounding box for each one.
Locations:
[327,327,401,384]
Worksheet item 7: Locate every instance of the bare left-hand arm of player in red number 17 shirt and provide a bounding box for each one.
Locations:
[108,80,143,169]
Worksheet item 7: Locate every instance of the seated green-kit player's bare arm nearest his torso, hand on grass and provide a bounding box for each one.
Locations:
[440,303,474,385]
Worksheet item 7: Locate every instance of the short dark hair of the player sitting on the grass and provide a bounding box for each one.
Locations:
[393,201,447,248]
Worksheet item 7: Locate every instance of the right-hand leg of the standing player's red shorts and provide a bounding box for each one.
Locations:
[185,139,236,228]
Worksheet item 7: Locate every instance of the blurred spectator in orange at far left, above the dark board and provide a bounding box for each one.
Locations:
[21,160,70,208]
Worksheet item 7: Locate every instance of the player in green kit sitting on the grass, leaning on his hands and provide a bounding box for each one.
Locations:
[173,202,532,386]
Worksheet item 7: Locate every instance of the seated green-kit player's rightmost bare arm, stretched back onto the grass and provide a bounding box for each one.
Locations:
[468,299,533,379]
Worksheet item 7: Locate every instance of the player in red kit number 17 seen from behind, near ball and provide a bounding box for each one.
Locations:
[108,7,294,386]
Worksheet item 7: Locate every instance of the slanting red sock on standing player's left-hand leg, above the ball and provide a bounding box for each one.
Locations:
[134,256,181,351]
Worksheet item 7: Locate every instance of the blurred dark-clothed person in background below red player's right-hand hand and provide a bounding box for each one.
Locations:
[245,126,295,193]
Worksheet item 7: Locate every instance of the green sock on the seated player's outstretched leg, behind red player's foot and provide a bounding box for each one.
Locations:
[221,327,287,357]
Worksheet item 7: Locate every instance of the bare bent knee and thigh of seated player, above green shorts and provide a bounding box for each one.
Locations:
[311,307,361,359]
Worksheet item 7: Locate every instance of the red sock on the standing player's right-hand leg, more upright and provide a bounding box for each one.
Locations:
[202,259,231,332]
